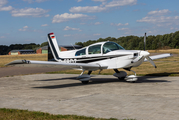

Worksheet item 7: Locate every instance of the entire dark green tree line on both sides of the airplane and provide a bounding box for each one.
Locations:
[0,31,179,55]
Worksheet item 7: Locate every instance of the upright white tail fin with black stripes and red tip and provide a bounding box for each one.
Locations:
[47,33,61,61]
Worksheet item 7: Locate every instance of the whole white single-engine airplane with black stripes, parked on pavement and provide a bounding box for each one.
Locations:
[7,33,171,84]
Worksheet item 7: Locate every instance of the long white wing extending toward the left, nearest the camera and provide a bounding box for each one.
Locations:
[6,60,107,70]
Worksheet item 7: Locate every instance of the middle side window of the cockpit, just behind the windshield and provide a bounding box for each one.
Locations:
[88,44,101,55]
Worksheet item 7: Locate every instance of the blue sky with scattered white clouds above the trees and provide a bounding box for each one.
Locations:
[0,0,179,45]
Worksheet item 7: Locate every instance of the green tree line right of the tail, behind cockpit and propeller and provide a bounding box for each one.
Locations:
[75,31,179,50]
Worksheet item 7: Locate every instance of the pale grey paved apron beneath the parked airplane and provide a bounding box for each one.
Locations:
[0,74,179,120]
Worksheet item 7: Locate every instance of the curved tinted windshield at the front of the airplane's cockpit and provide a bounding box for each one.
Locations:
[103,42,124,54]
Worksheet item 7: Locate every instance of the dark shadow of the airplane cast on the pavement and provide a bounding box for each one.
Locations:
[33,76,171,89]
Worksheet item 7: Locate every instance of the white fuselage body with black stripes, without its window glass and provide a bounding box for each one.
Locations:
[59,42,147,69]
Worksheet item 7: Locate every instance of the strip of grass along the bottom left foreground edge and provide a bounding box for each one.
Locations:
[0,108,134,120]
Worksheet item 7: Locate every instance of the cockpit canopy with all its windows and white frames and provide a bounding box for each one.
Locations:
[75,42,124,56]
